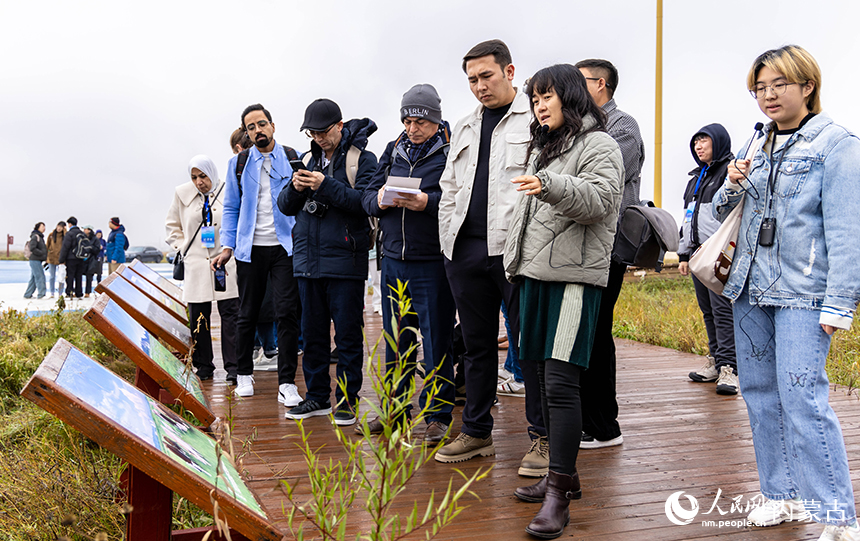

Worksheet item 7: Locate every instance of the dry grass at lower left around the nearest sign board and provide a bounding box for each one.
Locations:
[0,311,212,540]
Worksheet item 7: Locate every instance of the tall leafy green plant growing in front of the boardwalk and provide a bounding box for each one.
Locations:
[282,280,489,541]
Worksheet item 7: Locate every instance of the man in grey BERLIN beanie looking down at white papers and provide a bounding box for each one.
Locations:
[362,84,455,444]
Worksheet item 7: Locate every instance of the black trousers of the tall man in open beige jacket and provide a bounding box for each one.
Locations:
[445,237,546,438]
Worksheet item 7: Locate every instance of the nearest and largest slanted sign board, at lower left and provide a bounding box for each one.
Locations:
[21,339,283,541]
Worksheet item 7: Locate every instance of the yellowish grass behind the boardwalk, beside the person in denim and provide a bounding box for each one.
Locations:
[612,276,860,388]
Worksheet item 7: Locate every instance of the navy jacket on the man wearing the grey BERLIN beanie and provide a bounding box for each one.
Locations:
[362,126,450,261]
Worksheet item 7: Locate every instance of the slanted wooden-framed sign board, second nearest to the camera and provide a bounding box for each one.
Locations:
[84,294,215,426]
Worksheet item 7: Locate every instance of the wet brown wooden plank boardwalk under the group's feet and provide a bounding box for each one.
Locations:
[204,299,860,541]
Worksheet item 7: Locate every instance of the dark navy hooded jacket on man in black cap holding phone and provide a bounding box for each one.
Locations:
[278,118,376,280]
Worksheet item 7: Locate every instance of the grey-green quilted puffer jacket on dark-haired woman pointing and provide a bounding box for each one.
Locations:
[504,116,624,287]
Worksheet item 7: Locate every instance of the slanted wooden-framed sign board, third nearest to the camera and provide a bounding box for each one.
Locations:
[96,273,192,355]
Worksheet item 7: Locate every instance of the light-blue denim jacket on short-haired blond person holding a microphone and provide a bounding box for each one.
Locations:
[714,113,860,329]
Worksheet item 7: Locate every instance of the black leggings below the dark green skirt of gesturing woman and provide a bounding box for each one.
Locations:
[537,359,582,475]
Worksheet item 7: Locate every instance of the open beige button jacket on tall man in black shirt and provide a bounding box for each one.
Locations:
[439,92,532,259]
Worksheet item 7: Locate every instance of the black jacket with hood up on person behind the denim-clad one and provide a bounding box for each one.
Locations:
[678,124,733,261]
